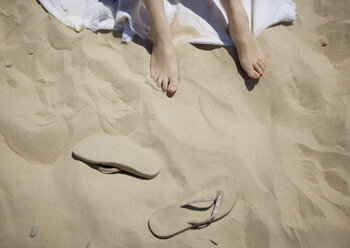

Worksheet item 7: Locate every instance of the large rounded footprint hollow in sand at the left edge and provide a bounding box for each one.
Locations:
[0,69,69,163]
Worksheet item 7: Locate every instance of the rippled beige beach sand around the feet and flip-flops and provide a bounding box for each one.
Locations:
[0,0,350,248]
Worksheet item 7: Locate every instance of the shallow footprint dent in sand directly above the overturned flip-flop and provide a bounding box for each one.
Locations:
[83,53,141,134]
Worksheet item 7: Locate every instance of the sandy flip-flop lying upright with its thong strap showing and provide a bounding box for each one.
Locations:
[148,179,238,239]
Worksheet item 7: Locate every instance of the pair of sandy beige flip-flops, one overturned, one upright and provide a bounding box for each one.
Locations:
[73,135,238,238]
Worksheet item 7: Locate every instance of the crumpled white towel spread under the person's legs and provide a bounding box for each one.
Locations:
[39,0,296,45]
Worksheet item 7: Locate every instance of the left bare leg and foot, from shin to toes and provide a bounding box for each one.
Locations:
[143,0,178,92]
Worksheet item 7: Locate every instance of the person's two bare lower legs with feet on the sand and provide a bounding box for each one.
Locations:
[143,0,267,92]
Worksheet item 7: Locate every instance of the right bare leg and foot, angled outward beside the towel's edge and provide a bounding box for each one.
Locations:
[221,0,267,79]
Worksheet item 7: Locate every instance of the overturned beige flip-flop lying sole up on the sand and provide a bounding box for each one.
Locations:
[73,135,161,179]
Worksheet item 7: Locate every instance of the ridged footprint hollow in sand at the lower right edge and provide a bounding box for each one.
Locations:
[297,144,350,226]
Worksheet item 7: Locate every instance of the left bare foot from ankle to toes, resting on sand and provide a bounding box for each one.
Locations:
[150,40,178,92]
